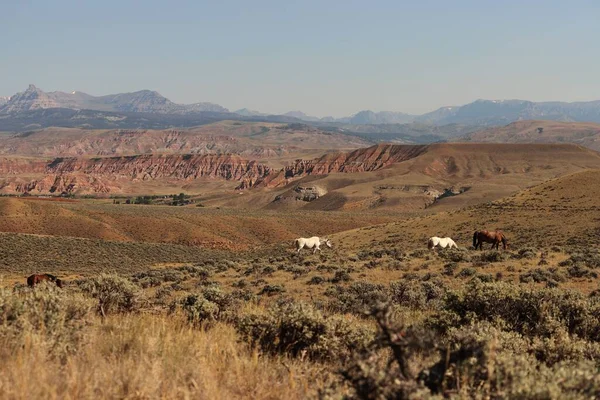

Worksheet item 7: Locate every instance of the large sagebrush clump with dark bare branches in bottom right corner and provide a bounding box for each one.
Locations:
[342,307,600,399]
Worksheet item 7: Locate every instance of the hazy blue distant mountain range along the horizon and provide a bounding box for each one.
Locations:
[0,85,600,134]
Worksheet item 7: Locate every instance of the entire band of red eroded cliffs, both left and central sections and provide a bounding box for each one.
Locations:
[0,145,427,194]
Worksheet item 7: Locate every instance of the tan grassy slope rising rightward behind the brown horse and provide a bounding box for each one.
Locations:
[334,170,600,251]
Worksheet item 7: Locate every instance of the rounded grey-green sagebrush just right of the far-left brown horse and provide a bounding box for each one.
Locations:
[79,273,140,316]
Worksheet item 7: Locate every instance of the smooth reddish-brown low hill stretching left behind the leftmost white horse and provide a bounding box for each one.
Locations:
[0,198,397,250]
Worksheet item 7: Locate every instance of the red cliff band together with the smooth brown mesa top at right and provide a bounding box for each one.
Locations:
[0,144,600,194]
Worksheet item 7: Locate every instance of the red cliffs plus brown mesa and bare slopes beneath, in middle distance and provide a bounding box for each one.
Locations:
[0,143,600,216]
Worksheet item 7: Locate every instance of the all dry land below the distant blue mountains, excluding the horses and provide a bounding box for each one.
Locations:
[0,121,600,399]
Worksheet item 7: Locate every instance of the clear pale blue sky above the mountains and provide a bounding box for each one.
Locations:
[0,0,600,117]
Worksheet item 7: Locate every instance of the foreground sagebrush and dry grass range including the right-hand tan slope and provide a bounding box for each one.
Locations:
[0,168,600,399]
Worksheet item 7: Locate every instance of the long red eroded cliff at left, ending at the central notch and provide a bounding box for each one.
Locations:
[0,154,271,193]
